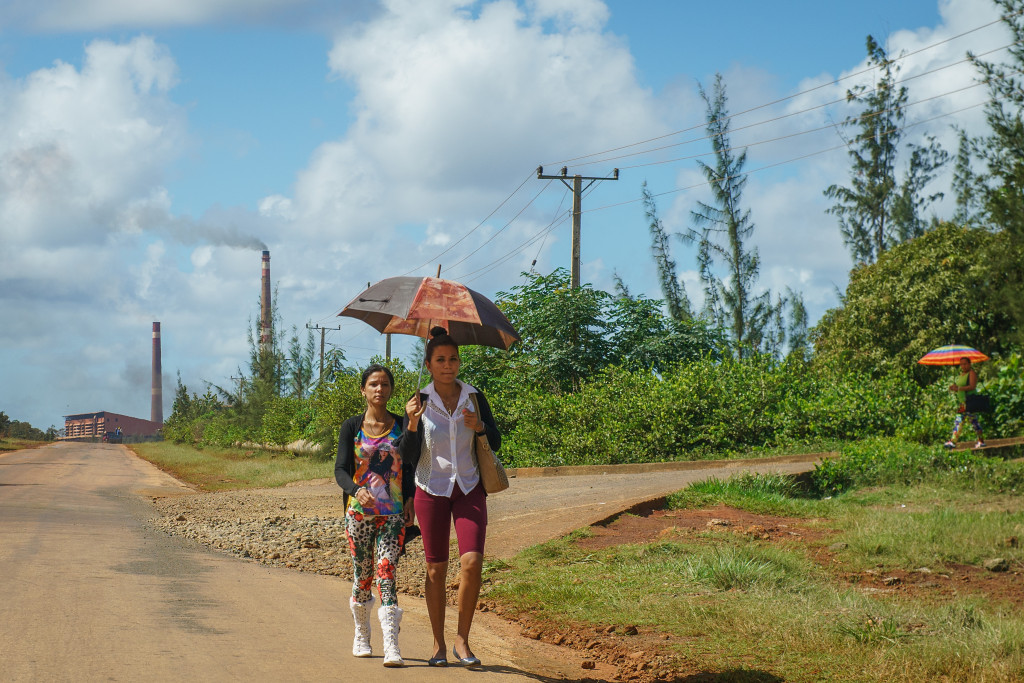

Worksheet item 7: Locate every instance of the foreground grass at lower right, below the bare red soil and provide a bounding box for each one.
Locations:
[487,535,1024,681]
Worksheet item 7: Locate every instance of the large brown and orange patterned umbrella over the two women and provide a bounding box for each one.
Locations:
[338,278,519,349]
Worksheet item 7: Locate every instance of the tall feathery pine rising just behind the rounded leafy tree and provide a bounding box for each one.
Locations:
[824,36,948,263]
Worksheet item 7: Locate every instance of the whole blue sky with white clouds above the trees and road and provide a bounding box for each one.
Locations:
[0,0,1009,427]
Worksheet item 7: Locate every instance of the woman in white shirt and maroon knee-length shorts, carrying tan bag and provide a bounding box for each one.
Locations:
[399,327,502,668]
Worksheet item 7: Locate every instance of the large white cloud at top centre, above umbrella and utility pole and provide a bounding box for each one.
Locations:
[295,0,660,237]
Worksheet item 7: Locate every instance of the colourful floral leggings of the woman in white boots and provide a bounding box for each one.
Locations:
[345,509,406,605]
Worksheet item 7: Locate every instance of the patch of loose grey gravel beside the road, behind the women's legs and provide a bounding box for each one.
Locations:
[154,486,458,597]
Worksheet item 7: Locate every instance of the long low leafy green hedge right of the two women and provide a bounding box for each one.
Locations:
[492,355,930,467]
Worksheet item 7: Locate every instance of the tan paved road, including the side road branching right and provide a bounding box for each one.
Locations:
[0,442,812,682]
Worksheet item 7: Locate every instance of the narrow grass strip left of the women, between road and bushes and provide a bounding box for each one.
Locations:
[128,441,334,490]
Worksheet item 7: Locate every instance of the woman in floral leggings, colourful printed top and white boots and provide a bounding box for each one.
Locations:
[334,365,415,667]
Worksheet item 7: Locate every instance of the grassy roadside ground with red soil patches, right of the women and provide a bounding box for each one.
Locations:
[484,439,1024,681]
